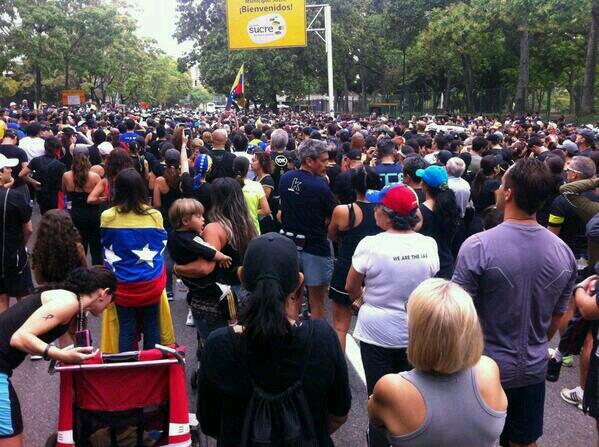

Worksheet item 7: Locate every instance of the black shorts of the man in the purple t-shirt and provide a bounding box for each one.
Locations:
[500,381,545,446]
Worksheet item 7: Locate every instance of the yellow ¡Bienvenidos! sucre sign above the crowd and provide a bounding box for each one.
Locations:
[227,0,307,50]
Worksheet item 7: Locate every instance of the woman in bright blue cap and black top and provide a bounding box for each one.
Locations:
[416,166,460,279]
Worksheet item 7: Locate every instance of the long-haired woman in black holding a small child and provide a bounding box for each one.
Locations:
[174,178,256,350]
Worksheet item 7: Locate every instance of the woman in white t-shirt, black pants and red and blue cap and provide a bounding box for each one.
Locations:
[346,184,439,394]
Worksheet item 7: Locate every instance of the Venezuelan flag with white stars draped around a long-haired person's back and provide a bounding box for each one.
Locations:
[100,207,168,307]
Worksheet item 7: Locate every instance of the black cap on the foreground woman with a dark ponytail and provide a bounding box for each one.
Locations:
[243,233,299,293]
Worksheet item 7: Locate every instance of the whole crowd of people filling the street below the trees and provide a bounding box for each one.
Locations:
[0,100,599,447]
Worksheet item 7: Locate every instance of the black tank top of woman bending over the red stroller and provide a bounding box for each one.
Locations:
[0,293,69,377]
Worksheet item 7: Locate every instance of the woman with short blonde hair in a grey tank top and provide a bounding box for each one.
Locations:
[368,279,507,447]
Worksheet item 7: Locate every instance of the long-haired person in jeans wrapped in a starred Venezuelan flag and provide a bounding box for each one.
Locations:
[100,168,172,352]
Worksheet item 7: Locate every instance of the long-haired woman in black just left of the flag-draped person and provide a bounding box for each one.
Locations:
[62,149,103,265]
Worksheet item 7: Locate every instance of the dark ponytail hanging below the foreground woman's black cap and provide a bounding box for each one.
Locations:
[240,278,291,350]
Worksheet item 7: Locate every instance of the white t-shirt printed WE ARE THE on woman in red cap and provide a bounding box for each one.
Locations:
[352,232,439,348]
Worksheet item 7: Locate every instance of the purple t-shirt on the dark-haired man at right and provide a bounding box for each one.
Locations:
[453,222,577,389]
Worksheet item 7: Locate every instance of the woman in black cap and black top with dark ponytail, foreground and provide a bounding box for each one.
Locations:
[197,233,351,447]
